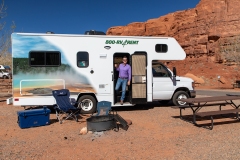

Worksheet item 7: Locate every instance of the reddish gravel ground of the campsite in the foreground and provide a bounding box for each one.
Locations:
[0,95,240,160]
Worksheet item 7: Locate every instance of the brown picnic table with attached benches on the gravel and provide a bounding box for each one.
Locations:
[172,95,240,129]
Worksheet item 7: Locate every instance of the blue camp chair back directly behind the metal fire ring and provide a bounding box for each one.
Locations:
[94,101,112,116]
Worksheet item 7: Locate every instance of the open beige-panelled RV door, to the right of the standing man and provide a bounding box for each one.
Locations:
[131,52,147,104]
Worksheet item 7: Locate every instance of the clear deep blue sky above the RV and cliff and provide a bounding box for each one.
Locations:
[1,0,200,34]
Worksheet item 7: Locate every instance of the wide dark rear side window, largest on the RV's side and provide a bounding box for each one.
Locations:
[29,51,61,67]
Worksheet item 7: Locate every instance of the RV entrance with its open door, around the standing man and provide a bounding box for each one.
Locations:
[113,52,147,105]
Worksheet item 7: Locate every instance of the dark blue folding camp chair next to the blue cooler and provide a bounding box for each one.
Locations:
[52,89,80,123]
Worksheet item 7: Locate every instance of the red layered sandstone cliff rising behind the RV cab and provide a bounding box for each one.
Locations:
[107,0,240,88]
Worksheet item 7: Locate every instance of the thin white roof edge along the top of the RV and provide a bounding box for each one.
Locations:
[13,33,172,39]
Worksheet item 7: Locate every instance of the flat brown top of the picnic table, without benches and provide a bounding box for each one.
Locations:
[177,96,240,103]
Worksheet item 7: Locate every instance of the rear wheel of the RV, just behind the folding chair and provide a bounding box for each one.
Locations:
[77,95,97,114]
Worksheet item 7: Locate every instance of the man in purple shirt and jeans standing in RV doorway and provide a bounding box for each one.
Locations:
[115,56,131,105]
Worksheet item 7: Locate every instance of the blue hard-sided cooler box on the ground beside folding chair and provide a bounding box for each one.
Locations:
[17,107,50,128]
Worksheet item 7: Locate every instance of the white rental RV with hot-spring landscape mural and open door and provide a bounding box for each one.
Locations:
[11,33,196,113]
